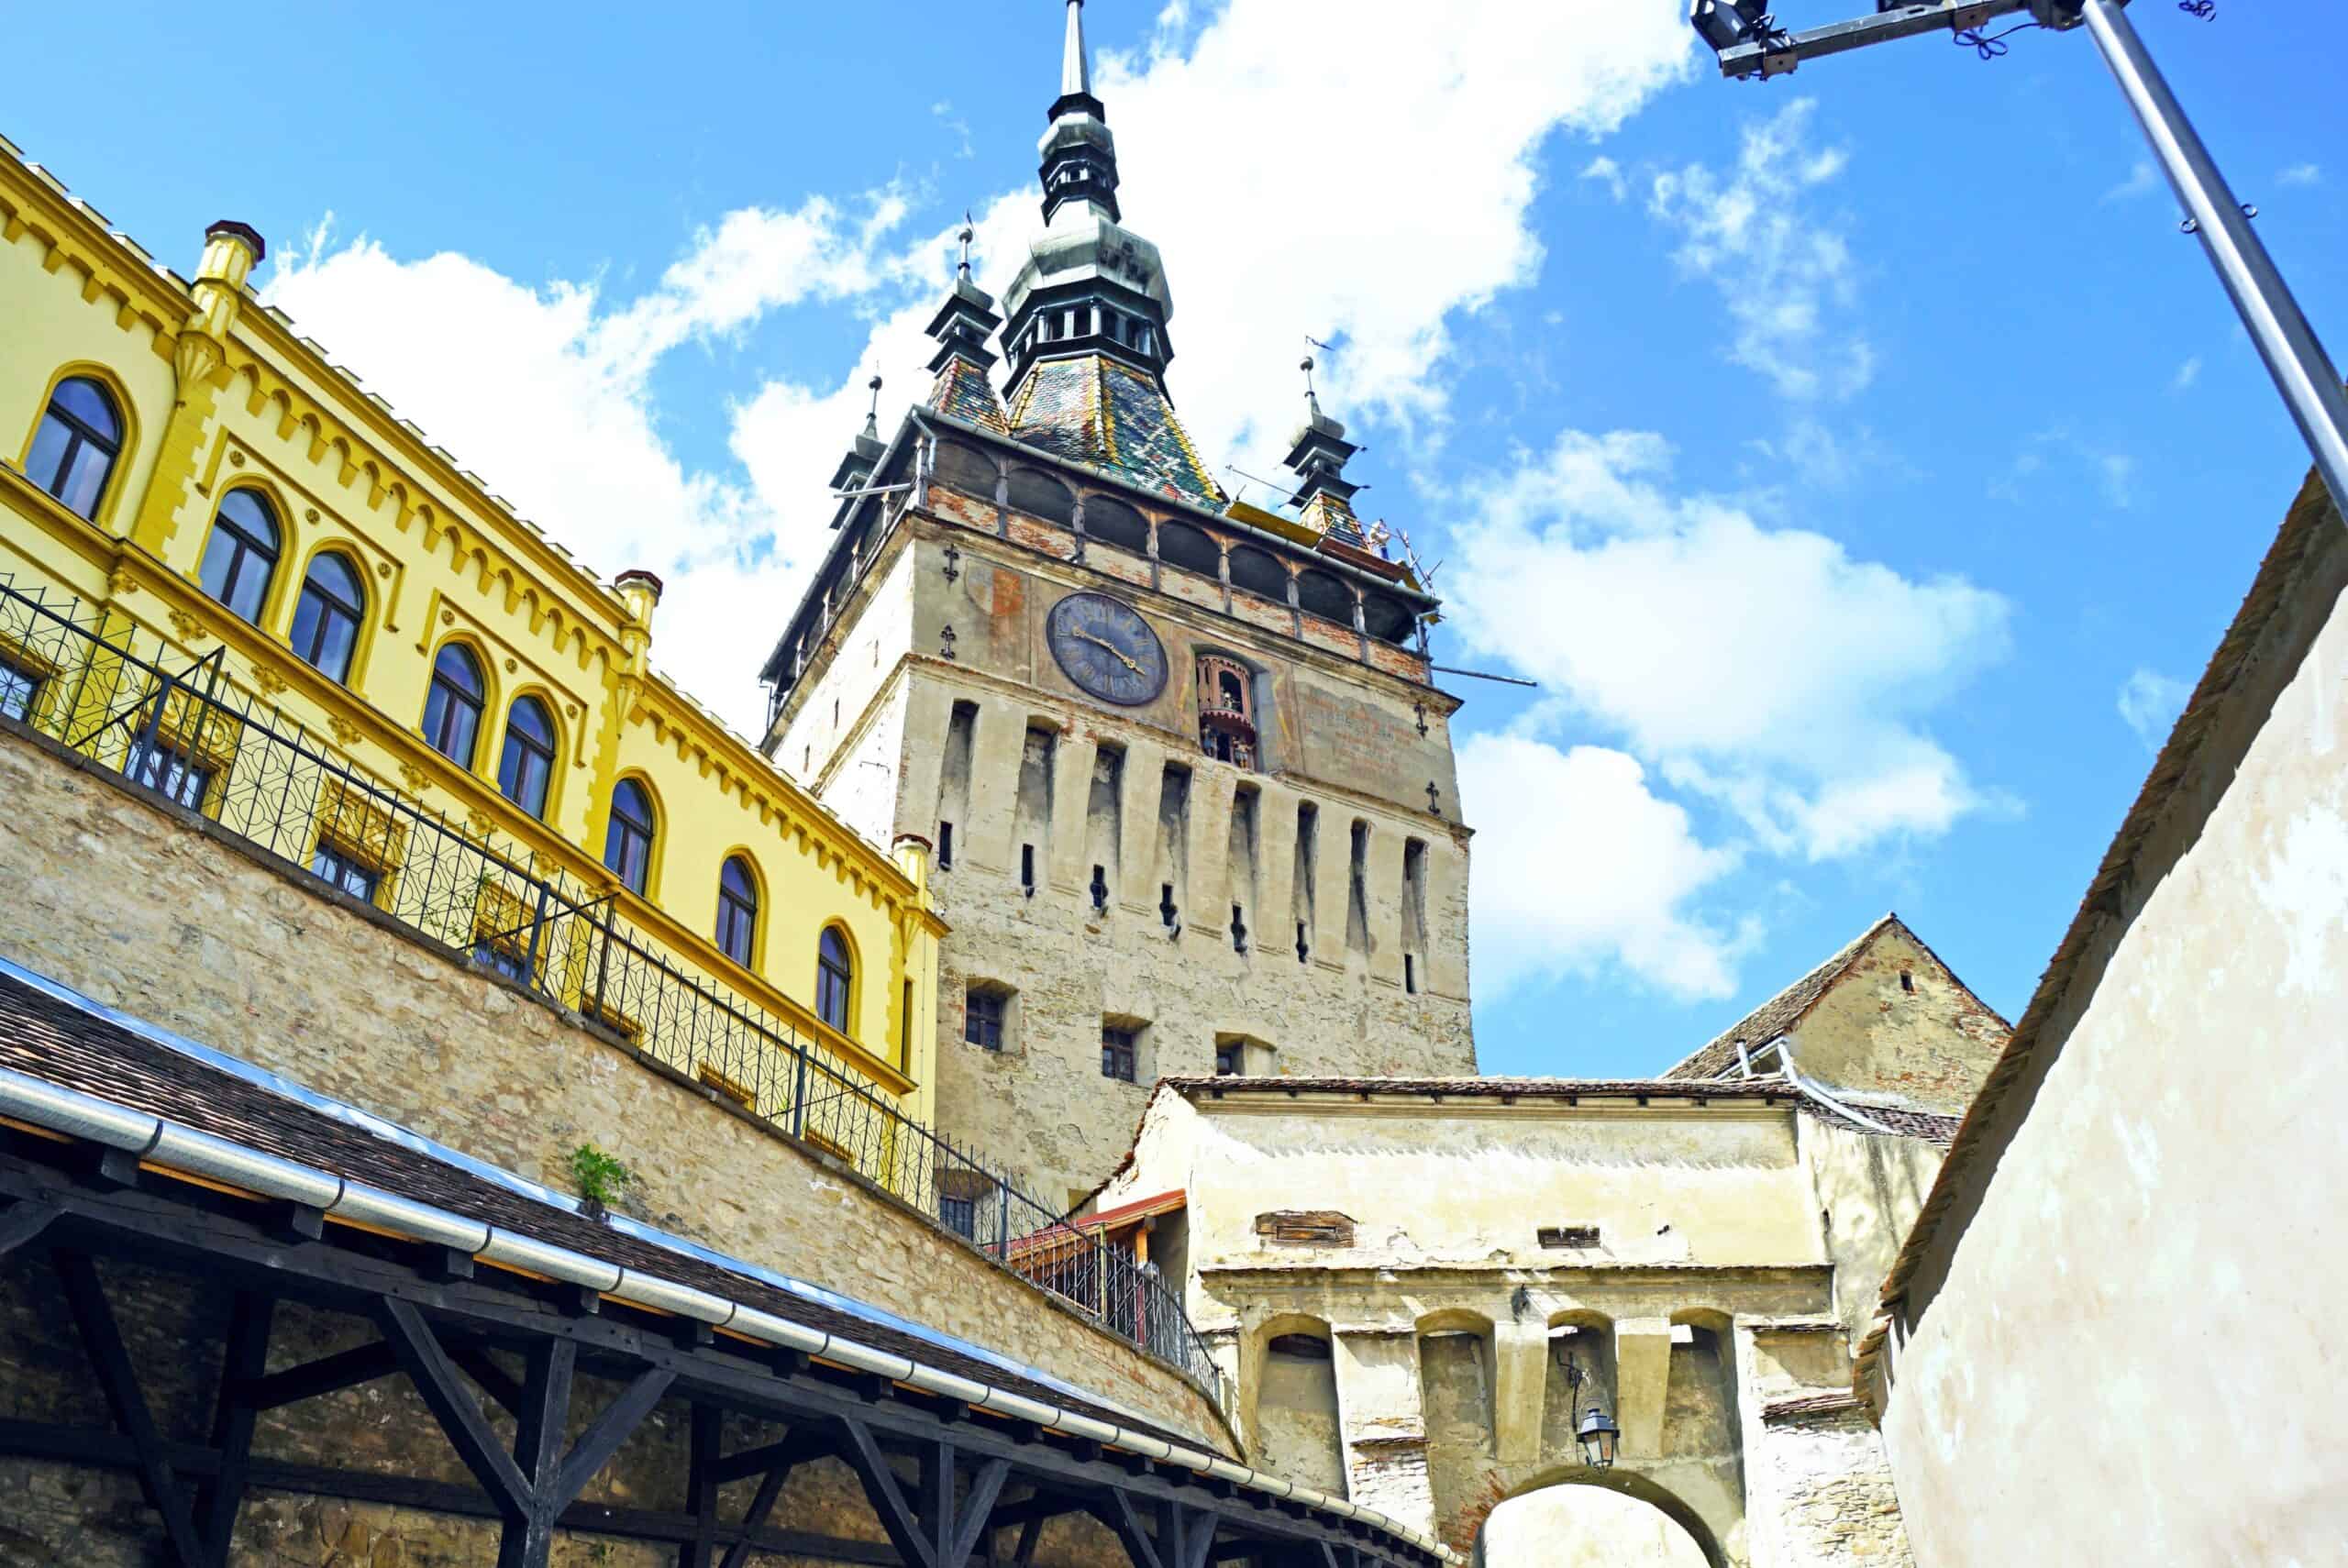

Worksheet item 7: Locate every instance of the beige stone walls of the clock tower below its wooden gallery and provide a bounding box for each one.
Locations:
[772,504,1475,1204]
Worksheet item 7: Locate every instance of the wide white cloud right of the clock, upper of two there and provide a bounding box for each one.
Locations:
[1444,432,2010,861]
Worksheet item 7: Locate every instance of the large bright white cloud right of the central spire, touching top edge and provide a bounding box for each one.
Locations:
[1089,0,1693,472]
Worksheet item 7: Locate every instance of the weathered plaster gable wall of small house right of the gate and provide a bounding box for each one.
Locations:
[1784,925,2008,1115]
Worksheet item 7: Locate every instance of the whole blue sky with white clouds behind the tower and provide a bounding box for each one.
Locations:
[14,0,2348,1073]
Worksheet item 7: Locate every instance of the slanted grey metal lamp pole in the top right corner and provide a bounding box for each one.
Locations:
[2088,0,2348,512]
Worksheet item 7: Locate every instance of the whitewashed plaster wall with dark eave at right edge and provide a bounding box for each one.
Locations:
[1883,495,2348,1568]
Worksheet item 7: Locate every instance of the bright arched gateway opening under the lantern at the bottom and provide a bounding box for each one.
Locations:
[1470,1464,1728,1568]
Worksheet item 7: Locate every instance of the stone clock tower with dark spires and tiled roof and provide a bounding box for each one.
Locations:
[763,0,1475,1202]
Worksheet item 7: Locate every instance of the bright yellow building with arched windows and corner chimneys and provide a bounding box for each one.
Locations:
[0,141,944,1141]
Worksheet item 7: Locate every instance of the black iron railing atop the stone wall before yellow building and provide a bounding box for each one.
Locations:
[0,575,1221,1397]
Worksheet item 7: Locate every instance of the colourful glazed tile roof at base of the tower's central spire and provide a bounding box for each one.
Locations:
[1010,355,1224,507]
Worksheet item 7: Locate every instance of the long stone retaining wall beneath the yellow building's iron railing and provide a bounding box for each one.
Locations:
[0,733,1230,1451]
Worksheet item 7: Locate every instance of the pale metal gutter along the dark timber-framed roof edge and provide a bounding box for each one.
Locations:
[0,1051,1458,1561]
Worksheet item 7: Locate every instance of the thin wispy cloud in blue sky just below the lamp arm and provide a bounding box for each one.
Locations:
[1648,99,1874,402]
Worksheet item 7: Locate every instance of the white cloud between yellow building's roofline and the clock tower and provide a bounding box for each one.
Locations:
[263,193,909,728]
